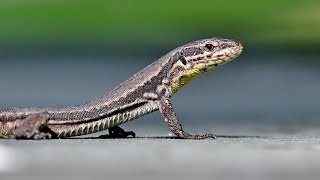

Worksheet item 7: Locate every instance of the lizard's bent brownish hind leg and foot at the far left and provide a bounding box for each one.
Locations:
[11,113,53,139]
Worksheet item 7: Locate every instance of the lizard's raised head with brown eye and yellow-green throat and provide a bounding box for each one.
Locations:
[171,38,243,93]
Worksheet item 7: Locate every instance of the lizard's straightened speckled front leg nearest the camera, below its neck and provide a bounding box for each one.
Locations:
[158,98,216,139]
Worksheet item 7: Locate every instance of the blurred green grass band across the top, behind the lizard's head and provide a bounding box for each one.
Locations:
[0,0,320,55]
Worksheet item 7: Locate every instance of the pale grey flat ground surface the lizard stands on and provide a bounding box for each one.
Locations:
[0,136,320,180]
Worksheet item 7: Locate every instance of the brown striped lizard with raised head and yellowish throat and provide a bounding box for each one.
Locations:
[0,37,243,139]
